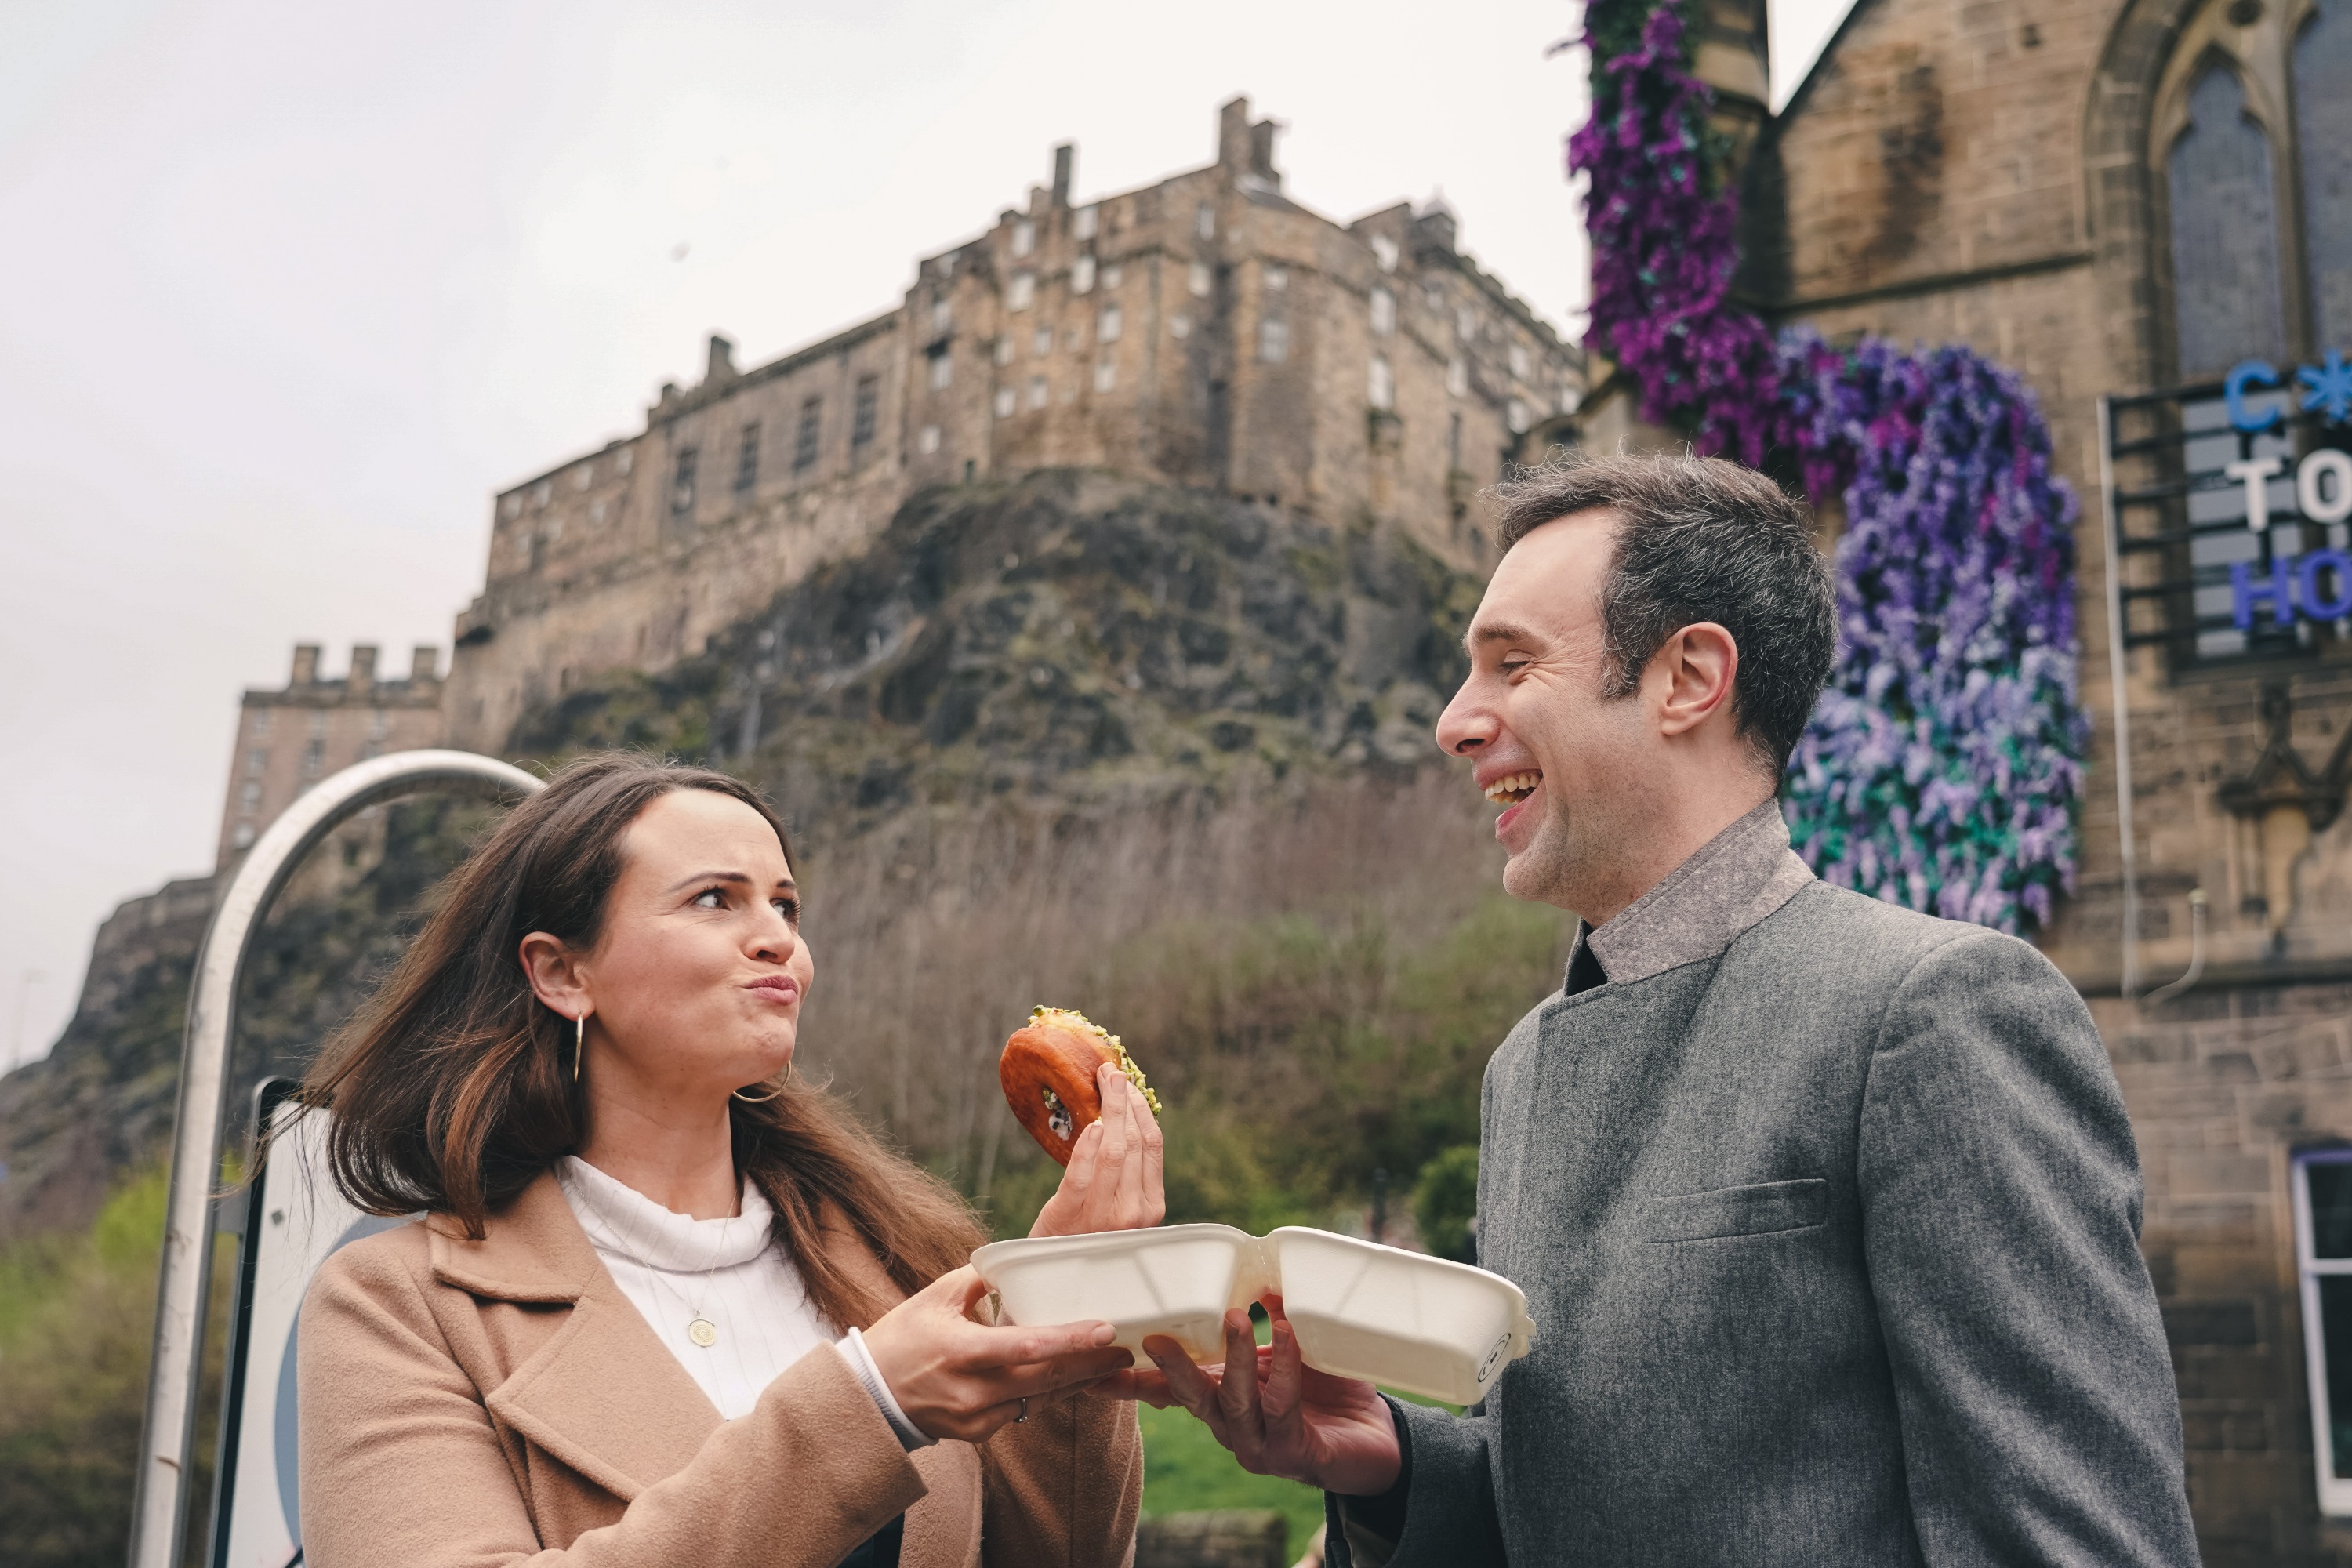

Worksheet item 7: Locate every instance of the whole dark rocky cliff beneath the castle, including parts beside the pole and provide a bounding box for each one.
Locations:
[0,473,1477,1239]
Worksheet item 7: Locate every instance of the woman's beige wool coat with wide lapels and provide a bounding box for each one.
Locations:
[296,1173,1143,1568]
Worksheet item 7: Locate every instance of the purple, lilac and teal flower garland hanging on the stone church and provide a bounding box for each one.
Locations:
[1569,0,2089,931]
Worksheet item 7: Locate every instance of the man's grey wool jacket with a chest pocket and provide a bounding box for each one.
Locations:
[1331,811,2197,1568]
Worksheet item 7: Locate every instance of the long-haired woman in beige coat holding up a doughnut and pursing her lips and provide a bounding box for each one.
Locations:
[299,755,1162,1568]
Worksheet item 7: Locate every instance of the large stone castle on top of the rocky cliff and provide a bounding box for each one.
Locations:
[207,99,1585,865]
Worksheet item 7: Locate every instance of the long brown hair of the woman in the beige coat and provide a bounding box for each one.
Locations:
[303,753,985,1328]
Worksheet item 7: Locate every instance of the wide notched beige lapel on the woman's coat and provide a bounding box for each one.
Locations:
[433,1171,720,1502]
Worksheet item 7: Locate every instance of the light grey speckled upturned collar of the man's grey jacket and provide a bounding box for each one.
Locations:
[1566,799,1813,994]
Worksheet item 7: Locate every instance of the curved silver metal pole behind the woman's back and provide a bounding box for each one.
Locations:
[129,750,539,1568]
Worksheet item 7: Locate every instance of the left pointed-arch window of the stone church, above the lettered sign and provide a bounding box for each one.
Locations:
[2166,61,2286,381]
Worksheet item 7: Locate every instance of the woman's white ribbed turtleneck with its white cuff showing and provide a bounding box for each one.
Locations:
[555,1154,931,1448]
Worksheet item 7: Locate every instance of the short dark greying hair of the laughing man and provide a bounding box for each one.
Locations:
[1489,454,1837,774]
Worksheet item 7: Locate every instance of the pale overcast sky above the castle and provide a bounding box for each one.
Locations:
[0,0,1837,1069]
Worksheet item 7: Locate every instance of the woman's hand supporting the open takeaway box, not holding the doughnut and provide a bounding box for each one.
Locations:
[863,1267,1134,1443]
